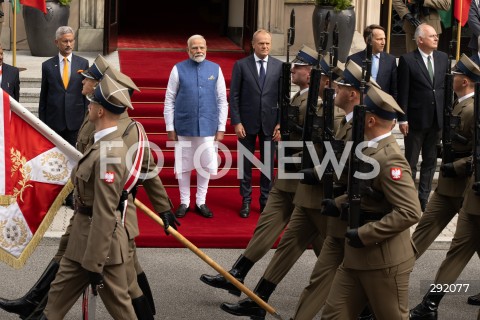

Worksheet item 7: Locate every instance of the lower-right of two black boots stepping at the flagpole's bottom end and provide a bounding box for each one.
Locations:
[220,278,277,320]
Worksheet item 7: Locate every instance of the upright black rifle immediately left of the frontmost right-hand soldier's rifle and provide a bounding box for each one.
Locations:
[322,23,338,199]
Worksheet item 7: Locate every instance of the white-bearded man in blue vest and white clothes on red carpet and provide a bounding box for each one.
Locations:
[164,35,228,218]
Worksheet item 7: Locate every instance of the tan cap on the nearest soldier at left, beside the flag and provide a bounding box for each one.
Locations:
[87,75,133,114]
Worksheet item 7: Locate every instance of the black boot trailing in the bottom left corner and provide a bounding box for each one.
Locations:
[0,260,59,319]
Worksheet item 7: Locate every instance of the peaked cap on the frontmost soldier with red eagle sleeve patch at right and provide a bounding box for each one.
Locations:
[363,86,405,120]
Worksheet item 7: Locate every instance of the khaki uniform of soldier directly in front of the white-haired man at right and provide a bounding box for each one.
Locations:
[412,96,474,259]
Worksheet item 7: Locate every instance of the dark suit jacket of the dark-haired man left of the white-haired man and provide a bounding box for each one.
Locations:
[347,50,397,100]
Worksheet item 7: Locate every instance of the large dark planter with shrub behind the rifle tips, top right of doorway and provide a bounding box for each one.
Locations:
[312,0,355,62]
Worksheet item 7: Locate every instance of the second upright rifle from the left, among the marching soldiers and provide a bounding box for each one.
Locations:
[302,13,330,169]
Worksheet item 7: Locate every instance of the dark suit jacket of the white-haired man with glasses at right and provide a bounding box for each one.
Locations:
[397,49,448,130]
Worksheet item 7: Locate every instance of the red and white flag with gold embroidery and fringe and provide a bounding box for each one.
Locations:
[0,90,81,268]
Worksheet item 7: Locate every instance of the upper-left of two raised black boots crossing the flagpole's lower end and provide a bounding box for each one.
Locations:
[200,255,254,297]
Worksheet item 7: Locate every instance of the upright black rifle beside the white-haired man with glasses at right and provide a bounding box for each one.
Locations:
[442,41,460,170]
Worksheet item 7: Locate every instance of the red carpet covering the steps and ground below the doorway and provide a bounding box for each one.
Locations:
[119,48,280,248]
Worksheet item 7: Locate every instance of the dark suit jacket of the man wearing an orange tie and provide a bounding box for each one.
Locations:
[38,55,88,132]
